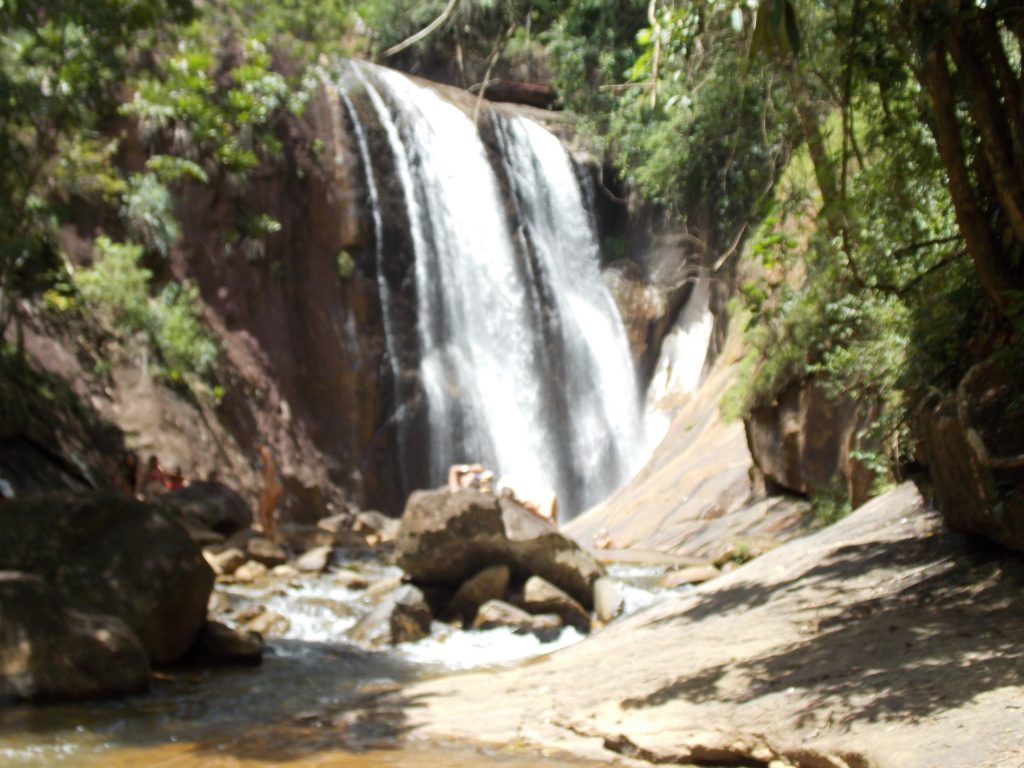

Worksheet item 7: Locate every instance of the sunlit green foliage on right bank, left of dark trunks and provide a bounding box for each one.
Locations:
[704,0,1015,499]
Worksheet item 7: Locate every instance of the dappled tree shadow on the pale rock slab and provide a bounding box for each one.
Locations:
[624,535,1024,722]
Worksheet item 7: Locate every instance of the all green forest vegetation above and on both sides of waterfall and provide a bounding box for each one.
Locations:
[0,0,1024,505]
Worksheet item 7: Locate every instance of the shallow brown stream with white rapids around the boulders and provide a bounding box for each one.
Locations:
[0,560,670,768]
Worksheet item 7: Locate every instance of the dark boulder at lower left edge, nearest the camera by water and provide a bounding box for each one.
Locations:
[0,571,150,701]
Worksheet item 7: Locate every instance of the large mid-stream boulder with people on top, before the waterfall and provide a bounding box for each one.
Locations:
[396,488,604,609]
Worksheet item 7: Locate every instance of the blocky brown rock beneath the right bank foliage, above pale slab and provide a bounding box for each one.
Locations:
[744,379,878,507]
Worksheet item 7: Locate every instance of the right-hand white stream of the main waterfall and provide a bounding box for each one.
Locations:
[491,118,642,505]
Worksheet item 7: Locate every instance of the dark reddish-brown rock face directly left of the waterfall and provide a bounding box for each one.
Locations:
[173,85,403,521]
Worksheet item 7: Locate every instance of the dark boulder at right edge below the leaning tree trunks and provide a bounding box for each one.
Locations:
[918,362,1024,551]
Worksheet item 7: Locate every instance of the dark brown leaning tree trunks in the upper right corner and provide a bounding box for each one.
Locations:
[900,0,1024,324]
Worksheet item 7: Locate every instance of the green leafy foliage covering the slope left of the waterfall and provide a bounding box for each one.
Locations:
[0,0,351,385]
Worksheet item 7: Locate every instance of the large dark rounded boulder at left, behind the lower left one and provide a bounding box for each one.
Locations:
[0,493,214,664]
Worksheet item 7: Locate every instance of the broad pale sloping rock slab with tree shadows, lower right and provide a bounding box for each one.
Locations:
[389,484,1024,768]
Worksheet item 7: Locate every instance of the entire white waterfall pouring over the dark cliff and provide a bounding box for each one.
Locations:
[348,65,642,515]
